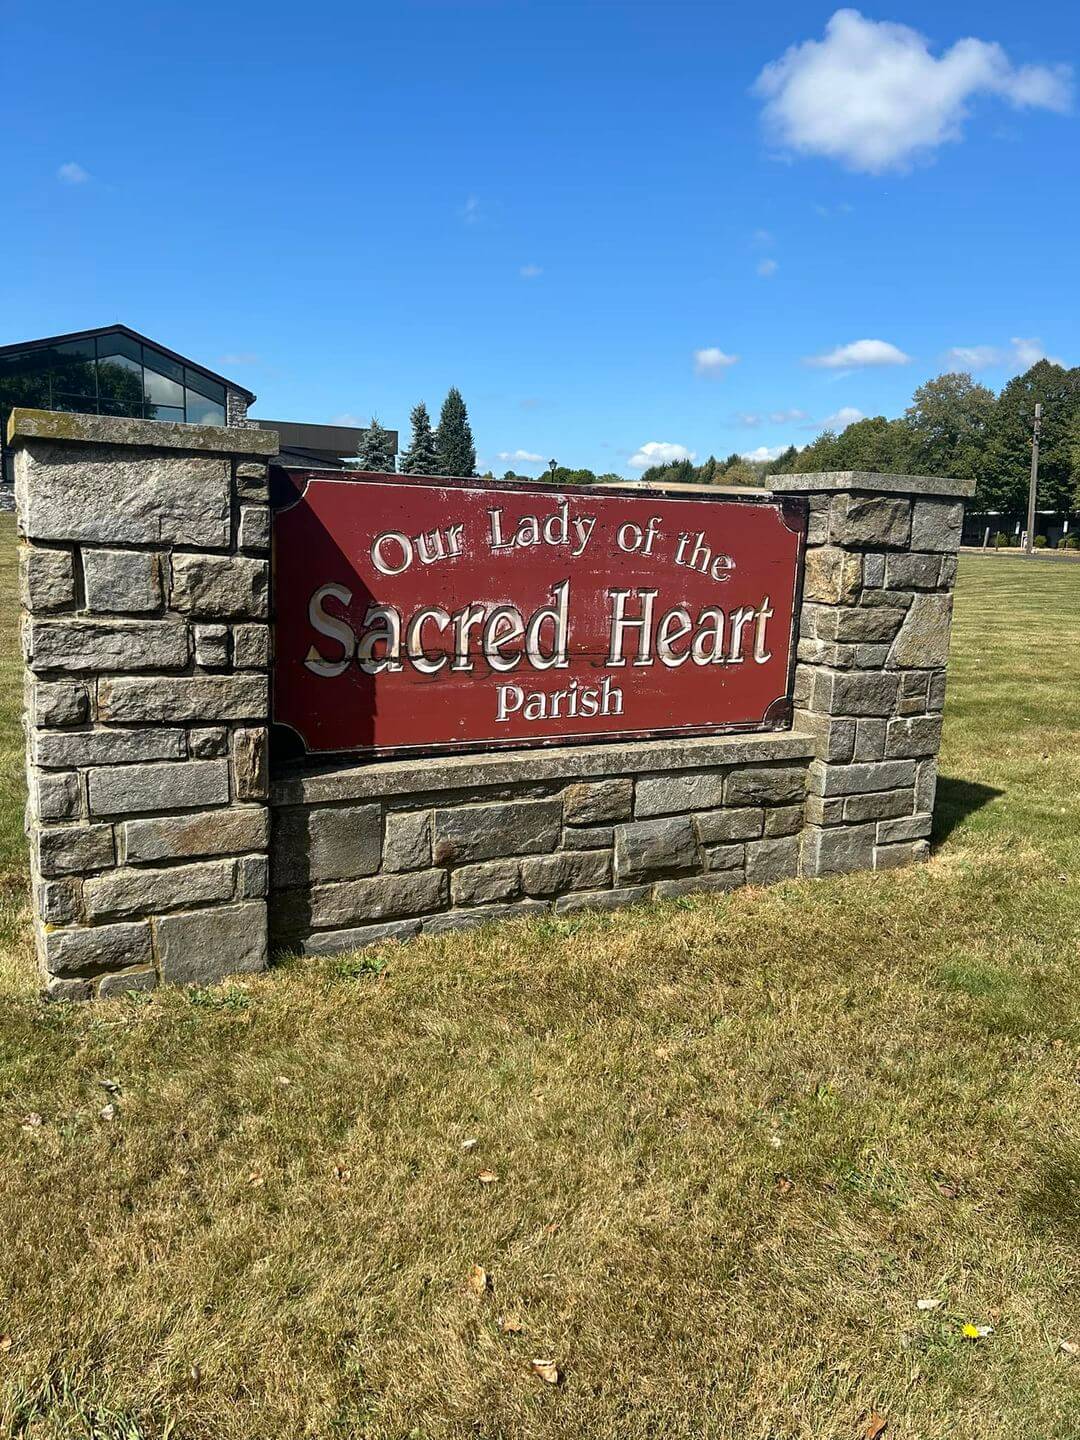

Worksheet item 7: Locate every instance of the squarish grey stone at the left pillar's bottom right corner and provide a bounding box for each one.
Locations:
[154,900,268,985]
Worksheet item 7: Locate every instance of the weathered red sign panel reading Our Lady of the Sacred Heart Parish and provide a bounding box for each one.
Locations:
[274,471,805,753]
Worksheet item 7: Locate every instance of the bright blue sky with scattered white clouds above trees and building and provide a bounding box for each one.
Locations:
[0,0,1080,475]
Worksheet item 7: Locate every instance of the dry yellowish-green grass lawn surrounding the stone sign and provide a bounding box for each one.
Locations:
[0,524,1080,1440]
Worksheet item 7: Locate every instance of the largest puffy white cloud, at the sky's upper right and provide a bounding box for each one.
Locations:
[755,10,1073,174]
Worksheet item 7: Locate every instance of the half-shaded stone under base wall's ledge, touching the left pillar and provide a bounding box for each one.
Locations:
[271,805,383,888]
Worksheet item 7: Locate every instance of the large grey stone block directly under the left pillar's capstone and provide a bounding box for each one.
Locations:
[19,441,229,549]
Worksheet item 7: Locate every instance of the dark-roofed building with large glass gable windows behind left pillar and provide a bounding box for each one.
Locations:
[0,325,397,510]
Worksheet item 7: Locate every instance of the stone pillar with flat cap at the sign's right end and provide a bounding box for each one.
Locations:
[776,471,973,876]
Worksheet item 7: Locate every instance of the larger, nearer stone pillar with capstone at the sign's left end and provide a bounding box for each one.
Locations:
[9,410,278,999]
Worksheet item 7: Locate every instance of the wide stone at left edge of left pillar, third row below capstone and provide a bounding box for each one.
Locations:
[27,619,189,668]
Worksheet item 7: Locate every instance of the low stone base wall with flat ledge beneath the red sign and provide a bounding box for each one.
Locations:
[271,734,814,953]
